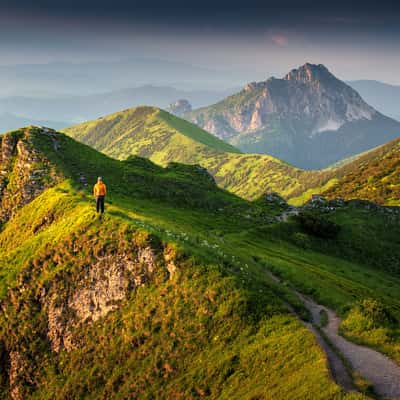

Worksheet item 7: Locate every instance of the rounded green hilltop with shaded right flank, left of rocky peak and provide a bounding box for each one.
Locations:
[66,107,239,159]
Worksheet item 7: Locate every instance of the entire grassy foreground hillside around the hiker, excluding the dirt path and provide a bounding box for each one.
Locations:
[0,127,400,400]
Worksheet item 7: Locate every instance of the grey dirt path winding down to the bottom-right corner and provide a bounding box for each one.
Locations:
[268,272,400,399]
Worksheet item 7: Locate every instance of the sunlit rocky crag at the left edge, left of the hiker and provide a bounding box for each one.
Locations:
[0,128,59,223]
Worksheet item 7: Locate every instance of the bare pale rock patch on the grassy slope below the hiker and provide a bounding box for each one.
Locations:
[41,247,161,353]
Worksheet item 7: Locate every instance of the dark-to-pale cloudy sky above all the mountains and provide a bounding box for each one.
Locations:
[0,0,400,85]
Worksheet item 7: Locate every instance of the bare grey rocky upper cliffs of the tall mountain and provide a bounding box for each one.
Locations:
[189,64,377,136]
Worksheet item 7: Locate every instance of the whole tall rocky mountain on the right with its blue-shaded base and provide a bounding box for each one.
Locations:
[185,63,400,168]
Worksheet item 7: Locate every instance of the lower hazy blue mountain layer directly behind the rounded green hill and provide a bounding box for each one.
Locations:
[0,85,235,132]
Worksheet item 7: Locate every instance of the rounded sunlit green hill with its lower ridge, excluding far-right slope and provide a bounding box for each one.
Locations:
[65,107,332,200]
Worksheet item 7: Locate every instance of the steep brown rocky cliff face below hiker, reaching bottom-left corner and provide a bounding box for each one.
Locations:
[0,231,178,400]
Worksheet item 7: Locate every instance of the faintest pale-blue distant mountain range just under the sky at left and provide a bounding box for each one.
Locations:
[0,56,248,97]
